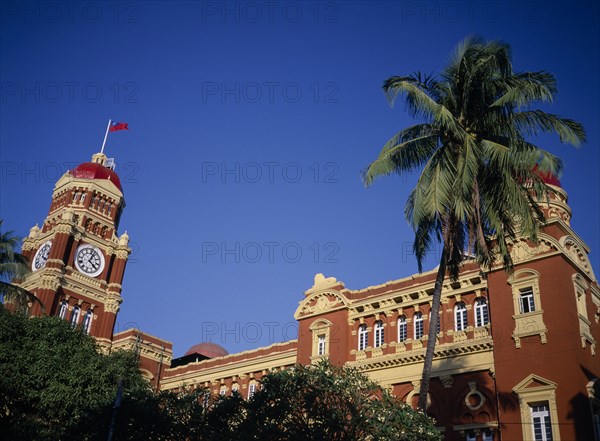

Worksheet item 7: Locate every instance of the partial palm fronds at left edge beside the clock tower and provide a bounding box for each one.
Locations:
[0,219,45,312]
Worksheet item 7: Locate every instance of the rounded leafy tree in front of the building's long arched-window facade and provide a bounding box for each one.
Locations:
[239,362,441,441]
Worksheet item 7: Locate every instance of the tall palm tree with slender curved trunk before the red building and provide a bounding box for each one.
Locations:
[362,37,585,411]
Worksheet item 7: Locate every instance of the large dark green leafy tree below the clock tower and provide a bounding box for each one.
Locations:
[0,305,165,440]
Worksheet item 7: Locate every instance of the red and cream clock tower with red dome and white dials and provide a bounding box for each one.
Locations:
[20,153,131,349]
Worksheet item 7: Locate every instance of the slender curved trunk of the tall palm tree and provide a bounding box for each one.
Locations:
[419,245,448,412]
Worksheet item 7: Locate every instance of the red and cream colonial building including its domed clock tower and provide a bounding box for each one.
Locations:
[16,155,600,441]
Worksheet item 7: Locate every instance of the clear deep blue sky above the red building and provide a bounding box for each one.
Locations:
[0,1,600,355]
